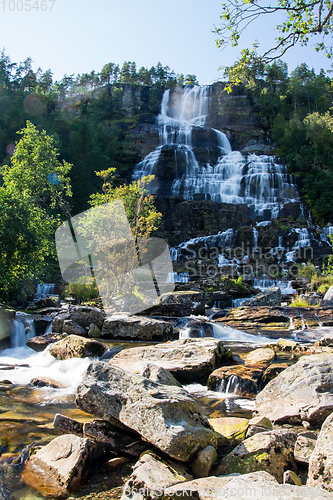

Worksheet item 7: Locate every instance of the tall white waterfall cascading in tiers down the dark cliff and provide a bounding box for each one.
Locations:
[134,86,299,219]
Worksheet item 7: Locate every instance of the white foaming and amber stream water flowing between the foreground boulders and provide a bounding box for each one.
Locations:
[0,318,314,500]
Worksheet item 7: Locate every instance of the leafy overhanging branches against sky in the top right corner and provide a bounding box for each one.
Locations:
[215,0,333,82]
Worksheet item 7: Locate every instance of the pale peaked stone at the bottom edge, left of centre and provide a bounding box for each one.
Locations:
[121,452,192,500]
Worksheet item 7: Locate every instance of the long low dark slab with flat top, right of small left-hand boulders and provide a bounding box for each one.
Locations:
[102,314,174,341]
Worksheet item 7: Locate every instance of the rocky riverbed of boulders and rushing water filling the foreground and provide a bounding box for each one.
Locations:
[0,297,333,500]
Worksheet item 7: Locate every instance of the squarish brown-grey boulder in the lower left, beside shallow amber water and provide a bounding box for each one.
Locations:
[23,434,99,498]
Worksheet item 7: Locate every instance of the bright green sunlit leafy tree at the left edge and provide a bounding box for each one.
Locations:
[0,121,71,300]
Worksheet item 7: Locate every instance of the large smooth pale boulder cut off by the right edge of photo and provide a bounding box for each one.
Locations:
[254,354,333,427]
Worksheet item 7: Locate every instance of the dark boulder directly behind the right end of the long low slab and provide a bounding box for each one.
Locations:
[146,290,205,317]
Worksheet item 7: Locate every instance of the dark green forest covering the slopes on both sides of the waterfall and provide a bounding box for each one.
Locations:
[0,51,333,301]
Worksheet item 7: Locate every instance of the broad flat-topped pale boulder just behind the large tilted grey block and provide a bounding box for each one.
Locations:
[109,337,230,384]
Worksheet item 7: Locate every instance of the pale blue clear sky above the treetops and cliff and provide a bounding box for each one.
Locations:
[0,0,331,85]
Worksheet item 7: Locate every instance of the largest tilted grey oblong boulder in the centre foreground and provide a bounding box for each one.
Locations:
[76,361,216,461]
